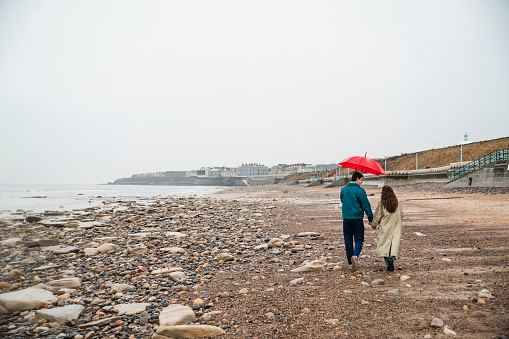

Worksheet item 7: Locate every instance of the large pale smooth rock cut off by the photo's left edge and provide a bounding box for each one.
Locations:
[0,288,57,314]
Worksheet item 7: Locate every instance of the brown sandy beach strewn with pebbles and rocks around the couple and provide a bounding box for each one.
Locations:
[0,185,509,339]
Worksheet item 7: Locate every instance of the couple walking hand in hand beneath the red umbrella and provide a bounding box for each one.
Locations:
[340,172,403,272]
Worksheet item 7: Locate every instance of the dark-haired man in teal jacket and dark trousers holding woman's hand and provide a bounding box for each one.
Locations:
[339,172,373,273]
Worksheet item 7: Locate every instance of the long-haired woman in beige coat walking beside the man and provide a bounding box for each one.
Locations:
[371,186,403,271]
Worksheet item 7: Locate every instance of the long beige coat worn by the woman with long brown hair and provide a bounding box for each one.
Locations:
[371,202,403,258]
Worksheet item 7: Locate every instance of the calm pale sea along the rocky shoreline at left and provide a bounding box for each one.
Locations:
[0,184,224,217]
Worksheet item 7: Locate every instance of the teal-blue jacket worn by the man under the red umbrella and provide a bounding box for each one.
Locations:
[339,182,373,222]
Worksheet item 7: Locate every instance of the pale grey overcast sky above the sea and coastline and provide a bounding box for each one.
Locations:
[0,0,509,183]
